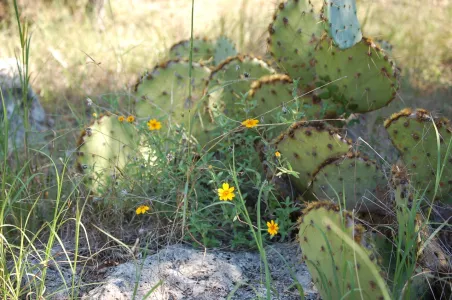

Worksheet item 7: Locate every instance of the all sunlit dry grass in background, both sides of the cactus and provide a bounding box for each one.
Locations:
[0,0,452,115]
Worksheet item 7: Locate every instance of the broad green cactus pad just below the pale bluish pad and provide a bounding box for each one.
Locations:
[316,38,399,113]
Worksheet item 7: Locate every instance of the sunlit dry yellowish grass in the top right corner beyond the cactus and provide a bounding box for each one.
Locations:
[359,0,452,89]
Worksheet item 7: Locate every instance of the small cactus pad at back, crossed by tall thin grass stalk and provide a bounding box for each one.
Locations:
[169,38,215,63]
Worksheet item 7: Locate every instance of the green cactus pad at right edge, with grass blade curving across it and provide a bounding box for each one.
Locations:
[385,109,452,204]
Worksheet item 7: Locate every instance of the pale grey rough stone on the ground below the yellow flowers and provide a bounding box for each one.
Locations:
[82,244,318,300]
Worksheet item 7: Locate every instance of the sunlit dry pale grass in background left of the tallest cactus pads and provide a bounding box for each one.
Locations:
[0,0,273,111]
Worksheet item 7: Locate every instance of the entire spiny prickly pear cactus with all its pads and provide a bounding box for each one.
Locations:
[78,0,452,299]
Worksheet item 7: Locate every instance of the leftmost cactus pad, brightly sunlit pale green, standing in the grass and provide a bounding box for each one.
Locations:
[77,115,141,194]
